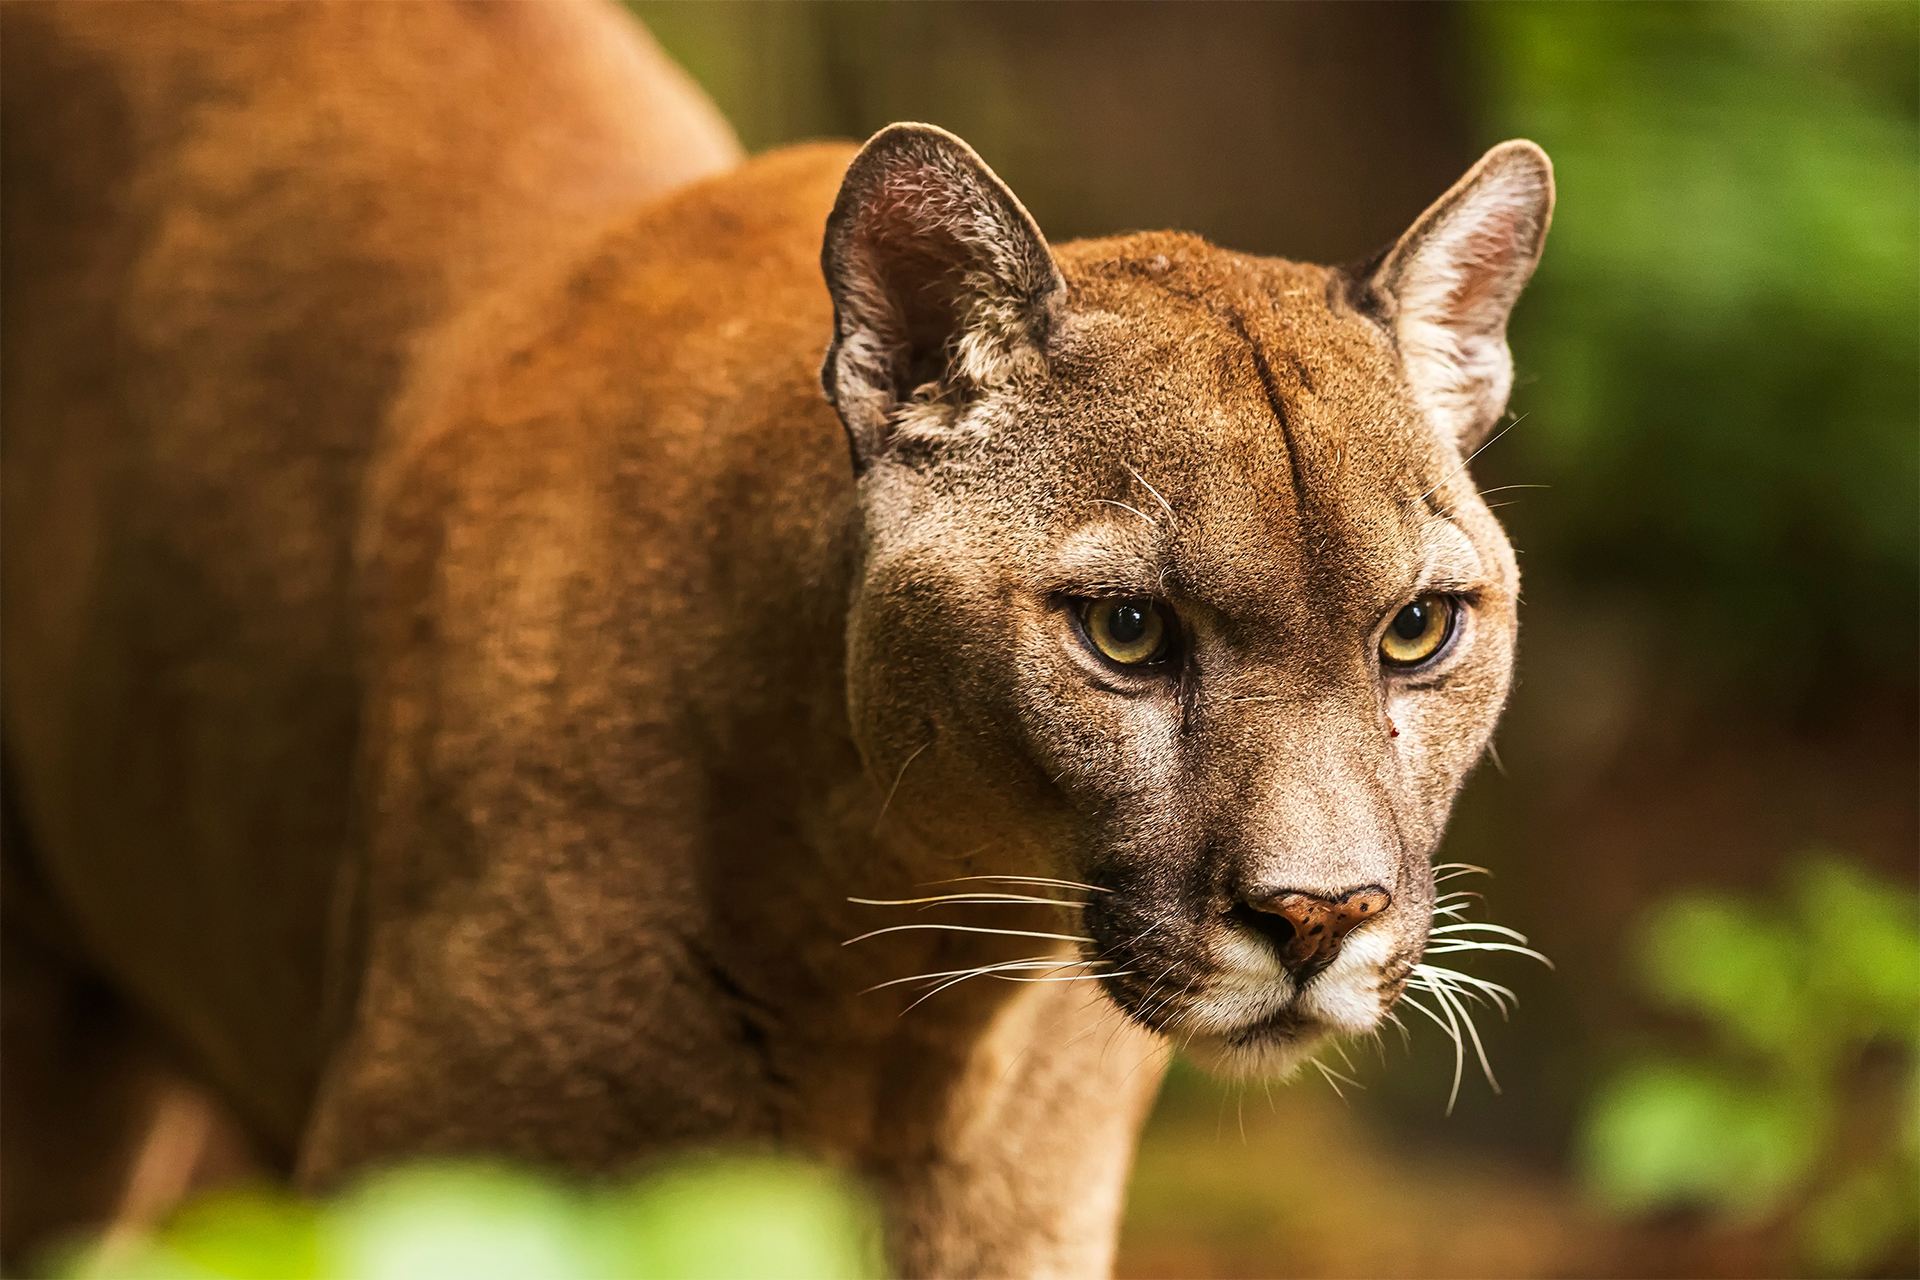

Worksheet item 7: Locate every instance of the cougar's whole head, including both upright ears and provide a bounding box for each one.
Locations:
[824,125,1553,1071]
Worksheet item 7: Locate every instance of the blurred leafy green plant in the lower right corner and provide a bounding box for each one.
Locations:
[1586,856,1920,1272]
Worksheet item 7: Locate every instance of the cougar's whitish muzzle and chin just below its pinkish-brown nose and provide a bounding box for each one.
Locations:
[1183,931,1392,1077]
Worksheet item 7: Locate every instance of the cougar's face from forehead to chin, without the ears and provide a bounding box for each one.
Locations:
[852,242,1517,1071]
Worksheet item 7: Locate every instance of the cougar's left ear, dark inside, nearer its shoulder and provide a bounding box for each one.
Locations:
[820,125,1066,470]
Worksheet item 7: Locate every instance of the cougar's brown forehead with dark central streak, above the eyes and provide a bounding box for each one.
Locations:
[998,236,1475,612]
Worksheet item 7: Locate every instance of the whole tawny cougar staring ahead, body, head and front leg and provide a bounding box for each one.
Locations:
[4,4,1551,1276]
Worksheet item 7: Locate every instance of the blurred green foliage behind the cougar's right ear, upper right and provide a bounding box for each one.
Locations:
[1469,0,1920,691]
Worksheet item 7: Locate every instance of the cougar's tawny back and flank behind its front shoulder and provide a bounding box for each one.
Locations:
[0,2,737,1150]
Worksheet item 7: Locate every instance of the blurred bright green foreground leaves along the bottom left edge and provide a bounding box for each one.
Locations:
[61,1157,883,1280]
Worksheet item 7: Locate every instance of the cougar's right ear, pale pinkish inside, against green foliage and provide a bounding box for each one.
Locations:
[1367,142,1553,453]
